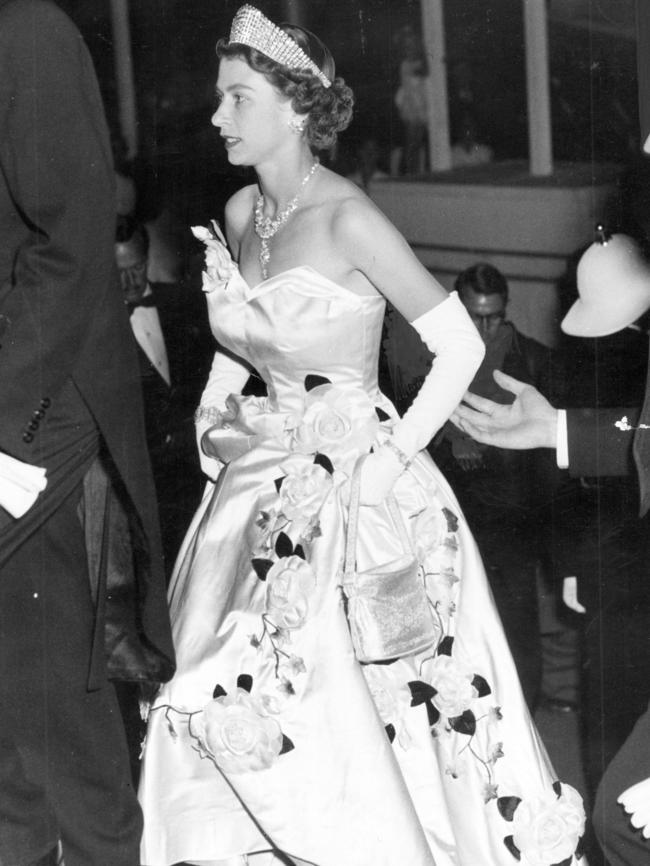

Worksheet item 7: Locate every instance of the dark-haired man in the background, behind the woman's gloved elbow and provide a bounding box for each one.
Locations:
[430,263,559,711]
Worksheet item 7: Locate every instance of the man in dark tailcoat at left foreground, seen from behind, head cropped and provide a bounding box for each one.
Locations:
[0,0,173,866]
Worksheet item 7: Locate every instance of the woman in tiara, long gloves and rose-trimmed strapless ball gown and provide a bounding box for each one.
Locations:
[140,6,584,866]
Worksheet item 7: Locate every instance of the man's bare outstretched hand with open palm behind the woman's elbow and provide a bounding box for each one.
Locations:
[451,370,557,450]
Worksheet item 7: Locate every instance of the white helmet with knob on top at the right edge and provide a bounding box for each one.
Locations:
[560,226,650,337]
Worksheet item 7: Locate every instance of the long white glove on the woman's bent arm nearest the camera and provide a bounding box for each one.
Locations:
[360,292,485,505]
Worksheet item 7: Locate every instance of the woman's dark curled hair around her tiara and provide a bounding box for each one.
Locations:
[217,24,354,150]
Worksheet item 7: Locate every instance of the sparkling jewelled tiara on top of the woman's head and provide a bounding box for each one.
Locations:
[229,4,332,87]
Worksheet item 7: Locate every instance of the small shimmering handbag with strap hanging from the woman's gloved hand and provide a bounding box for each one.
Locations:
[341,458,440,663]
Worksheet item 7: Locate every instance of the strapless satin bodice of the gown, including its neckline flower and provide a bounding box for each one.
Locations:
[193,222,394,415]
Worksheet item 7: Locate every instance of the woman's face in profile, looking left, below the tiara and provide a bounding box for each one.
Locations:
[212,57,292,165]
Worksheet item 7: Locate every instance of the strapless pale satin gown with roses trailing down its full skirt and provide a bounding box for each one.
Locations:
[140,241,584,866]
